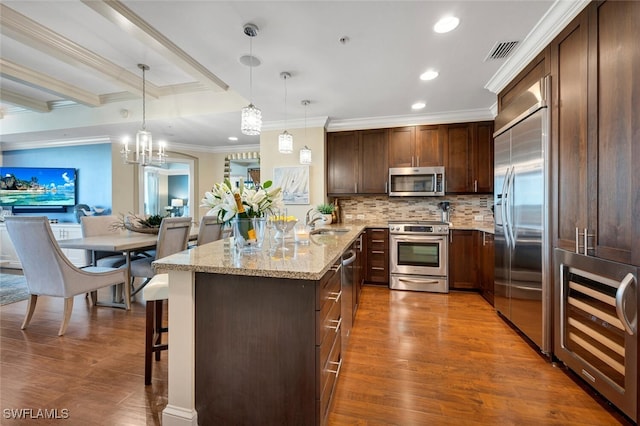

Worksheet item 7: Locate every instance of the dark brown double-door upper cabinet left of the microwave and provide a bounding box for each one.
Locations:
[327,129,389,196]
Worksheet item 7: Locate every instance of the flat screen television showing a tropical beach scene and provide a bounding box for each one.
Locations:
[0,167,77,208]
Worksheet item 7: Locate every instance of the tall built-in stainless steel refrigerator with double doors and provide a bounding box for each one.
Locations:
[494,75,553,354]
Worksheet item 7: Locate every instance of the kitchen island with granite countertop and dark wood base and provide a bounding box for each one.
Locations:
[154,226,364,425]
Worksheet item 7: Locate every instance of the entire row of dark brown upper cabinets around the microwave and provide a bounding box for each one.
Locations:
[326,121,493,196]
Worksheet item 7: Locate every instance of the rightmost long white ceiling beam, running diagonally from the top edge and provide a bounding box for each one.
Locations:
[82,0,229,91]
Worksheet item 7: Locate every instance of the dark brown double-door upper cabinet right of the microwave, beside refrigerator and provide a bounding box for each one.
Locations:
[445,121,493,194]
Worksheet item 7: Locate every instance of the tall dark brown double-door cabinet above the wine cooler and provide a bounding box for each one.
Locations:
[550,1,640,266]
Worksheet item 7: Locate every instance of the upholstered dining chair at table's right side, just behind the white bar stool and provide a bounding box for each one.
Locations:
[130,217,191,296]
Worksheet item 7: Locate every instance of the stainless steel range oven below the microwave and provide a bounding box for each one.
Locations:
[389,222,449,293]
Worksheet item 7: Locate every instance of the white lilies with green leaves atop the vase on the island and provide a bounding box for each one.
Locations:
[200,179,284,223]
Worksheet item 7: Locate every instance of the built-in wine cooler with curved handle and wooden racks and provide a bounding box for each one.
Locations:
[554,249,639,421]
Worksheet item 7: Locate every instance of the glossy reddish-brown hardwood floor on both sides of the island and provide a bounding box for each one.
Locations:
[0,286,630,425]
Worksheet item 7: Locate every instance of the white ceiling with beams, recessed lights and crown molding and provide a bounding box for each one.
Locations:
[0,0,588,151]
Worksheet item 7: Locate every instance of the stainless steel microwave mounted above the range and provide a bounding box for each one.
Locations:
[389,167,444,197]
